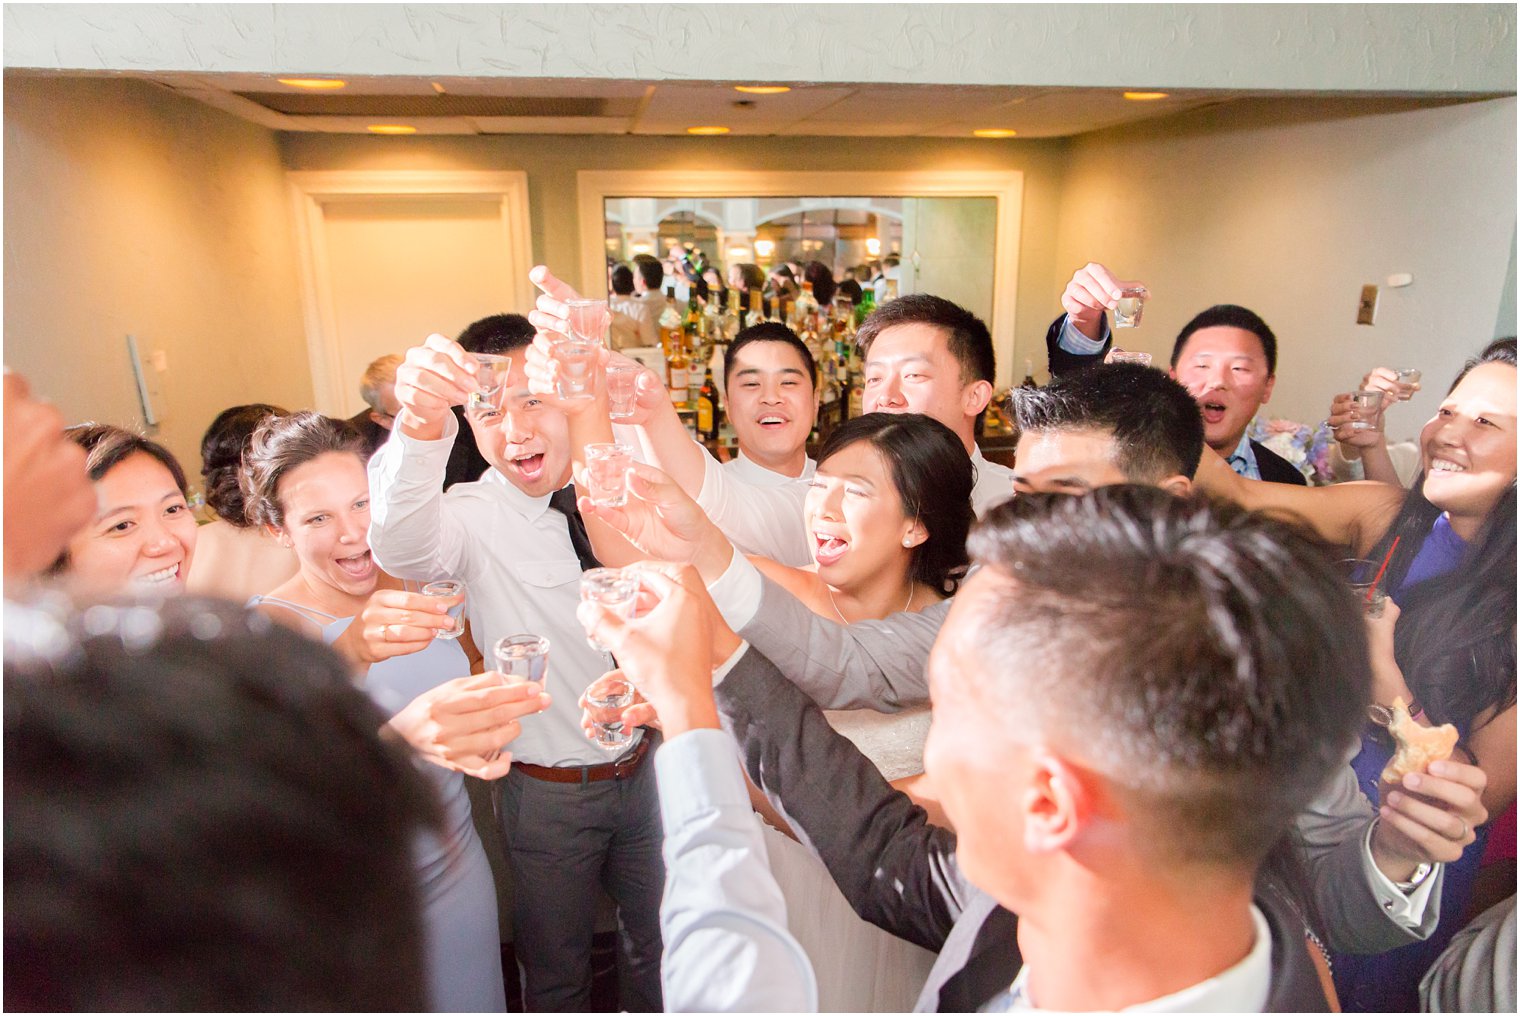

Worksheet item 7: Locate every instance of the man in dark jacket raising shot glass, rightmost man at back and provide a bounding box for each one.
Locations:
[1046,262,1307,485]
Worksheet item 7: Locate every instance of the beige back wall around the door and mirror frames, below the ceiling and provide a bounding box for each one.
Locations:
[281,127,1067,376]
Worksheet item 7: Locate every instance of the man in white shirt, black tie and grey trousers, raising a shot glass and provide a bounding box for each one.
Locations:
[369,329,664,1011]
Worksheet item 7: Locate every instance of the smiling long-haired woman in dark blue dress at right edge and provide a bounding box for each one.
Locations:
[1198,339,1517,1011]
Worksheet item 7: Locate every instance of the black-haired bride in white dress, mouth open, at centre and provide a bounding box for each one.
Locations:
[754,414,973,1011]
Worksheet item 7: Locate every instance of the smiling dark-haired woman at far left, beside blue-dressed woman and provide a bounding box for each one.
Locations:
[52,423,196,596]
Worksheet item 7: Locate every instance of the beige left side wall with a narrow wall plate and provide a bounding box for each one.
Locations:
[5,75,312,476]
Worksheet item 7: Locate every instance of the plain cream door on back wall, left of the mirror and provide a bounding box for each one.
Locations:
[322,198,516,415]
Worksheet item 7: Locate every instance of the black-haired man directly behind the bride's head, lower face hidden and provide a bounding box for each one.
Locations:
[857,294,1012,516]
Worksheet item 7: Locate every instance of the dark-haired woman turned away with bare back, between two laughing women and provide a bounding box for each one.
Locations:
[187,403,298,604]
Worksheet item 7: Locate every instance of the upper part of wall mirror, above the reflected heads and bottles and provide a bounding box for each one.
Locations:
[602,196,997,321]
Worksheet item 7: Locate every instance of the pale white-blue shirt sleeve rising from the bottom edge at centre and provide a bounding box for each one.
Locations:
[655,727,818,1013]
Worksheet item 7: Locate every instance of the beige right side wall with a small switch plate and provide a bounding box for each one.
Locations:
[1051,99,1515,438]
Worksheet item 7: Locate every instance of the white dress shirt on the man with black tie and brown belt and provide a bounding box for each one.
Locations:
[369,414,626,765]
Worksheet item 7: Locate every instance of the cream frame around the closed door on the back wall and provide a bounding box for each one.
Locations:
[286,170,534,415]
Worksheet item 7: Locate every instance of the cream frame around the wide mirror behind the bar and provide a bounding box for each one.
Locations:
[576,169,1024,385]
